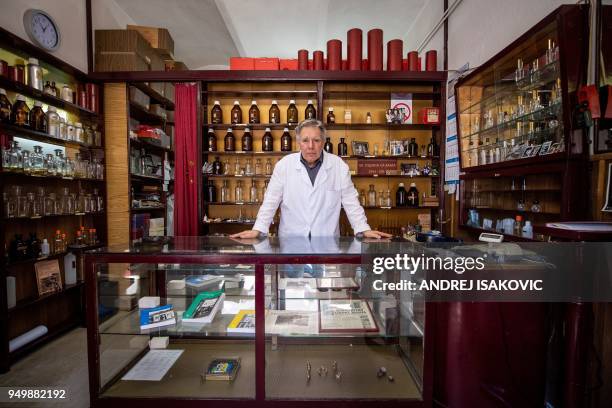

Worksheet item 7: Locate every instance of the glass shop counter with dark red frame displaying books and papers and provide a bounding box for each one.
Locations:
[85,237,435,407]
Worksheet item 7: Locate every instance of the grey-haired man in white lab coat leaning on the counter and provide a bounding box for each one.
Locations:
[232,119,391,238]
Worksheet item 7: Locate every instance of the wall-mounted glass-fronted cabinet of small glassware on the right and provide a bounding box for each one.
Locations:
[455,6,588,171]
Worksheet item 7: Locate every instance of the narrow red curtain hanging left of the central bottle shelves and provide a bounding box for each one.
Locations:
[174,84,199,236]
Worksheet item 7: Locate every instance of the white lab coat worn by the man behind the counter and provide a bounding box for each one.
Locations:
[253,152,370,237]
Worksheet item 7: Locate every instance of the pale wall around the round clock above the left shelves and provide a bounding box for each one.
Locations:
[0,0,88,72]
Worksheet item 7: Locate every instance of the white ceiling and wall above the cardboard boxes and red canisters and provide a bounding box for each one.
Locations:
[107,0,428,69]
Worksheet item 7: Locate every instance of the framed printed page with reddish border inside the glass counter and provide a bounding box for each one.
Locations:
[319,299,378,333]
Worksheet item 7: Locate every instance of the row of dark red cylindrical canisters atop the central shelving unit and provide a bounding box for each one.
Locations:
[297,28,438,71]
